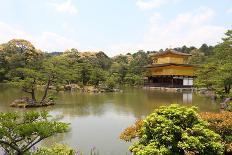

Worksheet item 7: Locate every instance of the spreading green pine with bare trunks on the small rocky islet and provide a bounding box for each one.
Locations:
[8,56,70,105]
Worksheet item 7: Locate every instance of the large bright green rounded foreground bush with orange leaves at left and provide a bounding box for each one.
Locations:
[120,105,224,155]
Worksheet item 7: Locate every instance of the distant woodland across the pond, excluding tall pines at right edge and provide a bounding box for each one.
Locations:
[0,39,214,87]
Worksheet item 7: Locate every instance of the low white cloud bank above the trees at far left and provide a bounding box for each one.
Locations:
[0,22,80,52]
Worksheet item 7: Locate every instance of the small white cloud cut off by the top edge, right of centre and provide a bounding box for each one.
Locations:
[136,0,179,10]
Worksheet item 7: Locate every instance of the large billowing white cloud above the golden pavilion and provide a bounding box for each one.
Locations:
[109,7,226,55]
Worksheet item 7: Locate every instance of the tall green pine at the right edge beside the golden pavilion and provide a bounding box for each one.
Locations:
[197,30,232,97]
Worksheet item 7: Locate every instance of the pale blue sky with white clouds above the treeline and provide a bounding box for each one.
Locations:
[0,0,232,56]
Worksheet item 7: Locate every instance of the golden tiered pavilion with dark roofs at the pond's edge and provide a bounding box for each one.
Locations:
[145,50,196,88]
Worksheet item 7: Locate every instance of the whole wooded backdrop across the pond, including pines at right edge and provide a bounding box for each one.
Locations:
[0,30,232,96]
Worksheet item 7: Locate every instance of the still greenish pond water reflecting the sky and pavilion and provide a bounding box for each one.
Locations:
[0,85,219,155]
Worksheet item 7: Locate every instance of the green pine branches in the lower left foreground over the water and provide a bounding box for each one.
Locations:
[0,111,68,155]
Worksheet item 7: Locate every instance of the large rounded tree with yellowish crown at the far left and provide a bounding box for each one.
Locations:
[0,39,43,80]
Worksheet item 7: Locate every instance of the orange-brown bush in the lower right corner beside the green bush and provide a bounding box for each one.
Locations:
[201,111,232,154]
